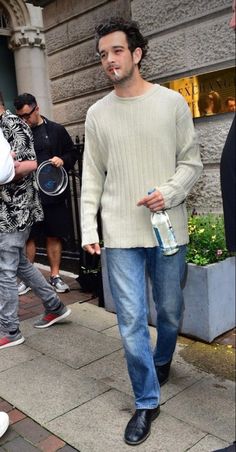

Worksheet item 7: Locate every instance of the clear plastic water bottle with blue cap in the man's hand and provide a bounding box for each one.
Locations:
[148,189,179,256]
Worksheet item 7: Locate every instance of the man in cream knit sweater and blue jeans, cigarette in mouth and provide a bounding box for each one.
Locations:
[81,18,202,445]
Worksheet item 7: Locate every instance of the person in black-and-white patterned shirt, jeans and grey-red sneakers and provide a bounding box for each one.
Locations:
[0,93,71,349]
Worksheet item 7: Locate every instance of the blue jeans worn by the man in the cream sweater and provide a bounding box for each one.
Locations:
[106,246,186,409]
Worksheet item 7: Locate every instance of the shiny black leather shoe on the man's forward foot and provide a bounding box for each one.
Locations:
[124,406,160,446]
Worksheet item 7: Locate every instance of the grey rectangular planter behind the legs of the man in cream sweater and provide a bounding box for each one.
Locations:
[101,249,235,342]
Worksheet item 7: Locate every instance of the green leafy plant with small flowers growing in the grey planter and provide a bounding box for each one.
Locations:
[186,214,231,266]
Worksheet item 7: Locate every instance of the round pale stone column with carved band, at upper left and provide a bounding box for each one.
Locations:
[9,26,52,118]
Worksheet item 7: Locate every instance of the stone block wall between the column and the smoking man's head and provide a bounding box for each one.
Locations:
[40,0,131,137]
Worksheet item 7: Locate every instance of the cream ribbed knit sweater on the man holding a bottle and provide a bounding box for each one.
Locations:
[81,84,202,248]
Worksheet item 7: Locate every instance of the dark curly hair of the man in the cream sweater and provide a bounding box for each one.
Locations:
[95,17,148,67]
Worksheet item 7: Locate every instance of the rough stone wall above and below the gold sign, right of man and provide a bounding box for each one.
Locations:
[131,0,235,212]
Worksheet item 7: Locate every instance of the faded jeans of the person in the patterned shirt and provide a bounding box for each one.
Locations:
[0,228,61,333]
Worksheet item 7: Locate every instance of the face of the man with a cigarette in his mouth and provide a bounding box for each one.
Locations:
[98,31,140,84]
